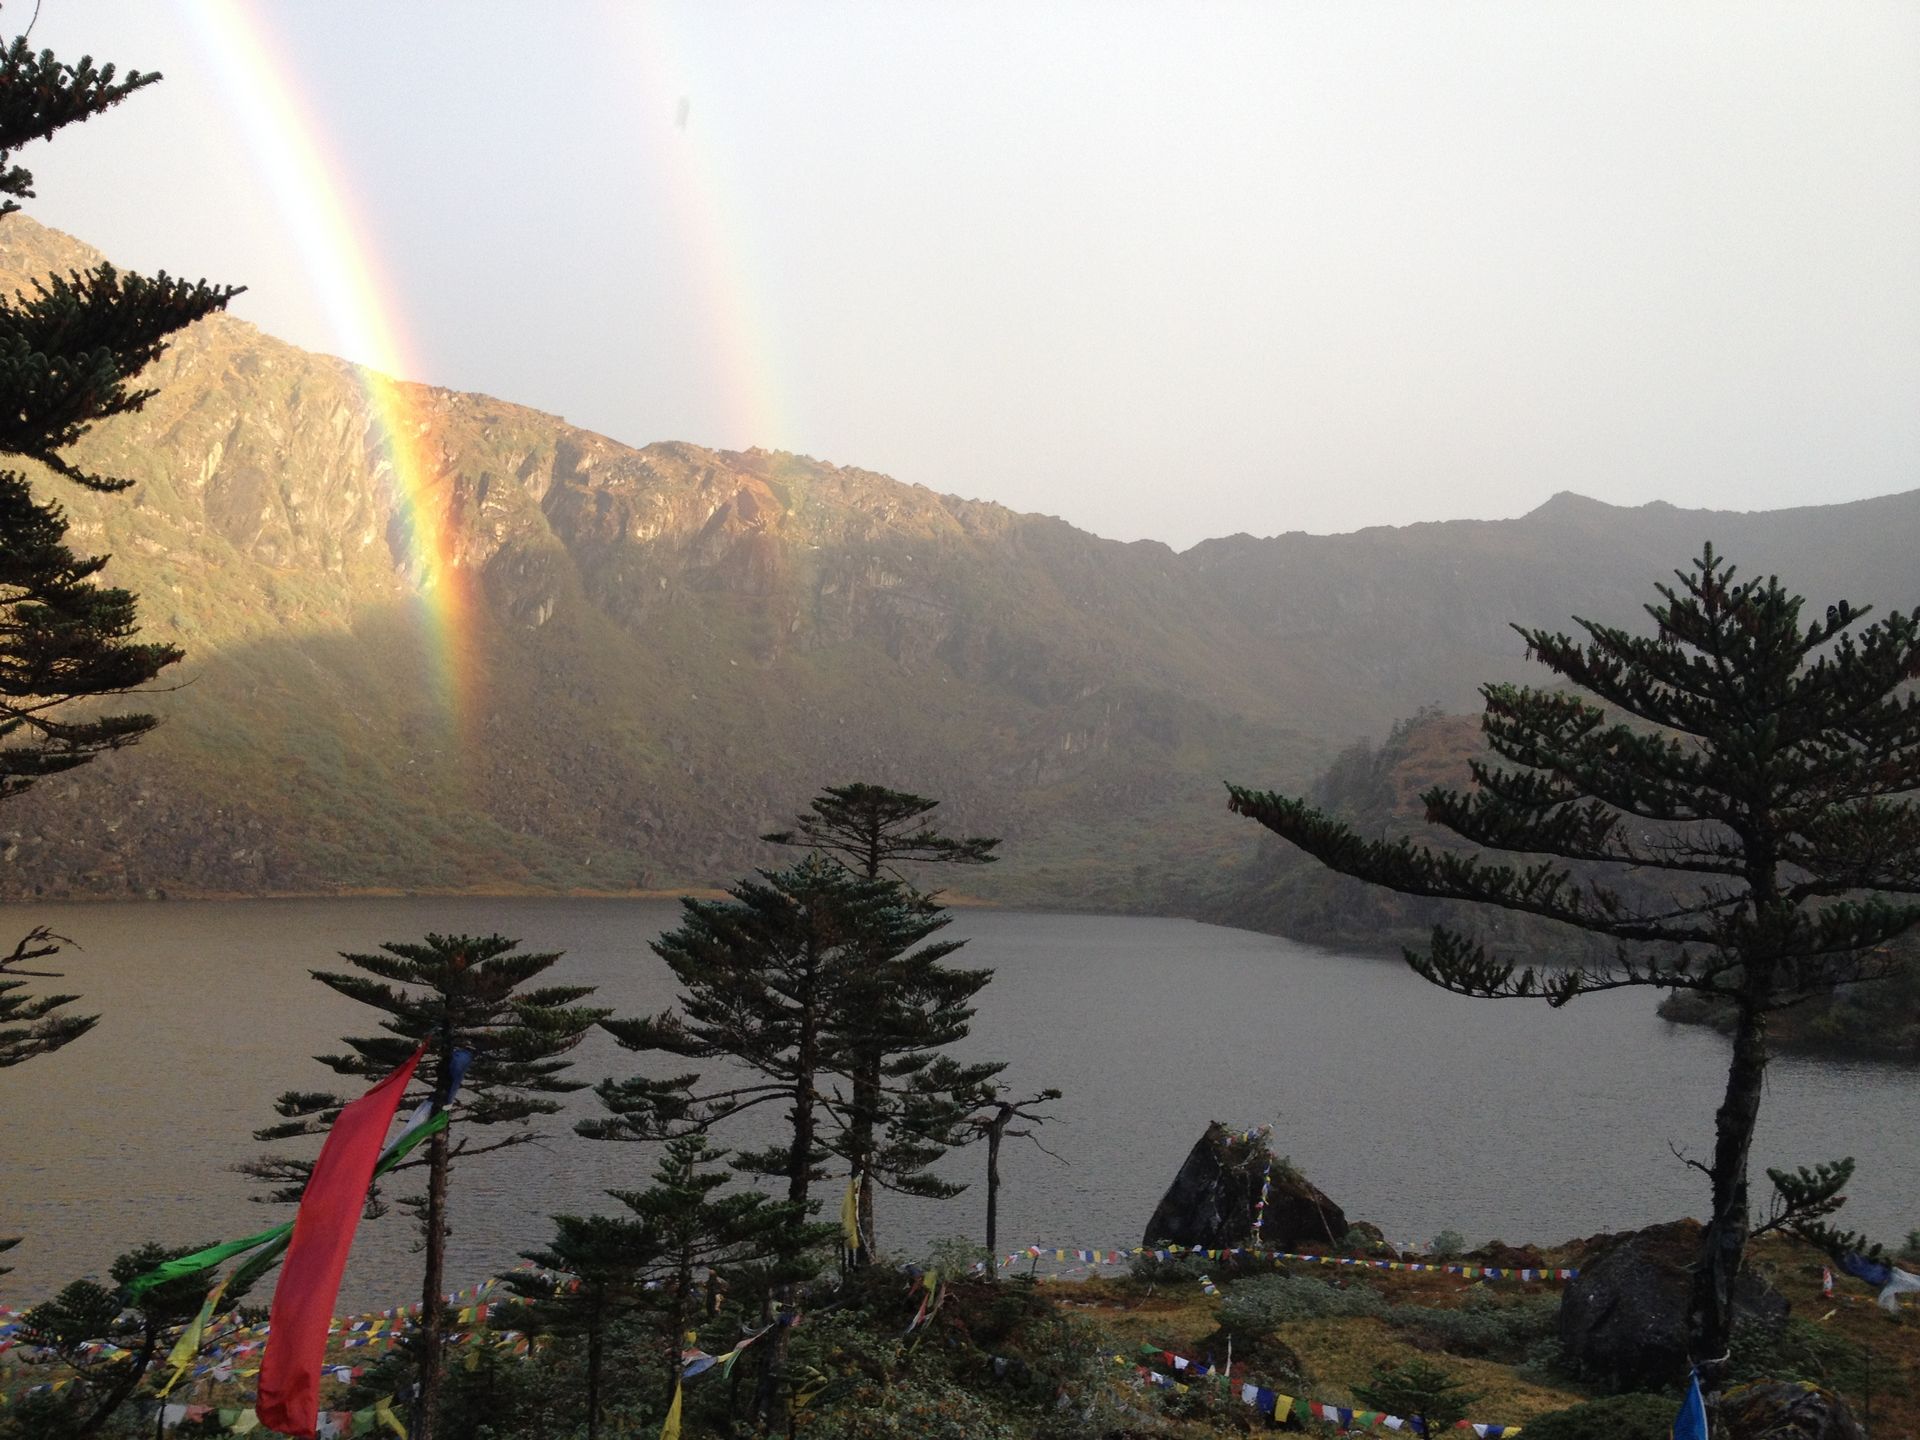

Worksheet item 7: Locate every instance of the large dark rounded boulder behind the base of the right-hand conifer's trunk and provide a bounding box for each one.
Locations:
[1559,1219,1788,1390]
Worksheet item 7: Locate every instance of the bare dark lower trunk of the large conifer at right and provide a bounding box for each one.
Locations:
[1688,990,1772,1390]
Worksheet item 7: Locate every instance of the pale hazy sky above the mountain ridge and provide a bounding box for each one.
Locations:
[15,0,1920,545]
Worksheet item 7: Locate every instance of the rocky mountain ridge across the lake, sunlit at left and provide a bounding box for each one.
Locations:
[0,215,1920,914]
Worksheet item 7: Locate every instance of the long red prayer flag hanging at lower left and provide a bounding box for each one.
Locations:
[253,1044,426,1438]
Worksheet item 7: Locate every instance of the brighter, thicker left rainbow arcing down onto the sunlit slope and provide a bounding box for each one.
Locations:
[180,0,474,726]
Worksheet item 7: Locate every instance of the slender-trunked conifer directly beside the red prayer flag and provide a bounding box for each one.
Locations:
[240,935,609,1440]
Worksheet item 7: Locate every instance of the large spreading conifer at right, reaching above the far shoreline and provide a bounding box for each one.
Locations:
[1229,545,1920,1380]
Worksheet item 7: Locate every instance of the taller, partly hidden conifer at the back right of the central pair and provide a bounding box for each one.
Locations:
[760,781,1000,1254]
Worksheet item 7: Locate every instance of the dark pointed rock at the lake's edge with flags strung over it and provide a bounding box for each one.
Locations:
[1142,1121,1348,1250]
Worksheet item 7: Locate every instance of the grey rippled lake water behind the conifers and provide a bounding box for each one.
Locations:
[0,899,1920,1306]
